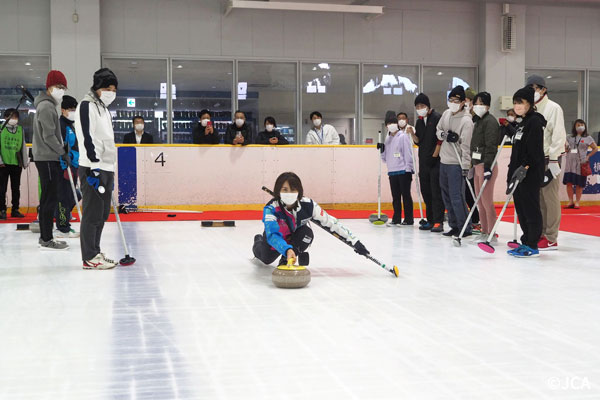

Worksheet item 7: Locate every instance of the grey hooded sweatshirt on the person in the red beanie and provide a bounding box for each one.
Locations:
[32,91,65,162]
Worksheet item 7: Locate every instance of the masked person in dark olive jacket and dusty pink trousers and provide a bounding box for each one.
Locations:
[471,92,499,240]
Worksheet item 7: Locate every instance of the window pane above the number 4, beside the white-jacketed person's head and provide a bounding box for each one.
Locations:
[103,58,167,143]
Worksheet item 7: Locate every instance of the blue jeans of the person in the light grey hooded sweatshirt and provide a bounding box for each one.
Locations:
[440,163,472,233]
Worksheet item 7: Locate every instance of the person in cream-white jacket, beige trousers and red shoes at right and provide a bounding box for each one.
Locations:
[526,75,567,251]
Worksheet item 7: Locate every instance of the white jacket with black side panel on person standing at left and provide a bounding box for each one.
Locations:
[75,92,117,172]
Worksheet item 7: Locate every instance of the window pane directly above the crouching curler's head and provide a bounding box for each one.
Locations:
[237,61,297,143]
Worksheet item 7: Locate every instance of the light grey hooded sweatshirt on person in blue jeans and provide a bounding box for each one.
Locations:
[437,110,473,169]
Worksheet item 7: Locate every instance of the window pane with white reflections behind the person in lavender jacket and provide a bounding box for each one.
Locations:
[362,65,419,143]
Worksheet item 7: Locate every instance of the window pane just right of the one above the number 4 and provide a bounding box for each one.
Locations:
[172,60,233,143]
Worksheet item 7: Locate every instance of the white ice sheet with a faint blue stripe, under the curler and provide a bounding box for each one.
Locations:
[0,219,600,400]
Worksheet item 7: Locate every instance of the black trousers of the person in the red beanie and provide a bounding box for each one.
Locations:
[35,161,63,242]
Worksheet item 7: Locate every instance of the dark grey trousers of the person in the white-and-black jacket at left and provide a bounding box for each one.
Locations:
[79,167,115,261]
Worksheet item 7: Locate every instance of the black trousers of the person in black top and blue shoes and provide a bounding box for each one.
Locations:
[514,179,542,249]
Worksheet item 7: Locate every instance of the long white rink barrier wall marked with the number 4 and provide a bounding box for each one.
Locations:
[8,144,600,212]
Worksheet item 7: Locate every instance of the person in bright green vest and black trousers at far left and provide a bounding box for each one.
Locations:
[0,108,29,219]
